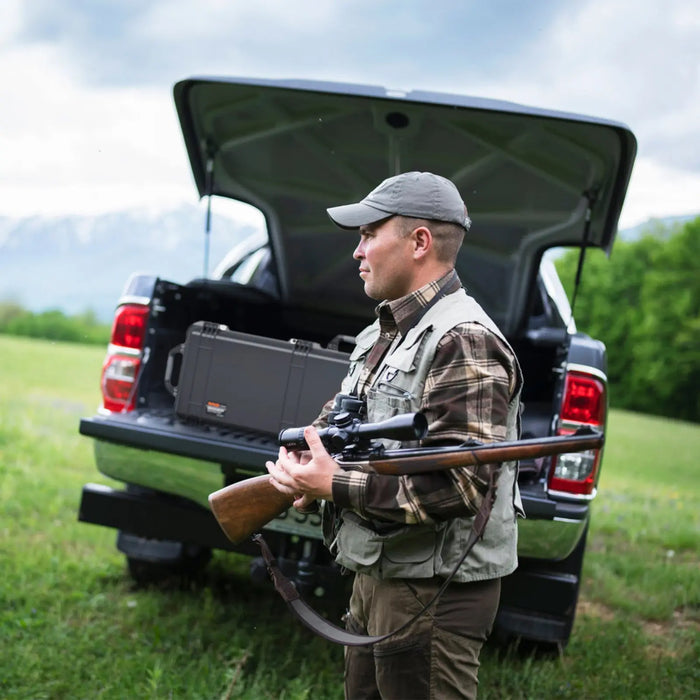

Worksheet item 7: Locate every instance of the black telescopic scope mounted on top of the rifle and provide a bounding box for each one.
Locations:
[278,413,428,452]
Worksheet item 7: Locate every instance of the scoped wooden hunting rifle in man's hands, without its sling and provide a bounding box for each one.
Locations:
[209,412,604,544]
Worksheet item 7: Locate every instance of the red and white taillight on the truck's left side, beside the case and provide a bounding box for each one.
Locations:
[102,304,148,412]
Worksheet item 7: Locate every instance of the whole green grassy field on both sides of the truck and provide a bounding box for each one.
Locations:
[0,335,700,700]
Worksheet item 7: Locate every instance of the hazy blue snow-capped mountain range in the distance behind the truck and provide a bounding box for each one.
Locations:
[0,204,693,322]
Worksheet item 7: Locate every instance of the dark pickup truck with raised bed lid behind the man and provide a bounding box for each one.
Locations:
[79,77,636,646]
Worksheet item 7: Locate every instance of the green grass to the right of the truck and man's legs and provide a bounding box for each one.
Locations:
[480,411,700,699]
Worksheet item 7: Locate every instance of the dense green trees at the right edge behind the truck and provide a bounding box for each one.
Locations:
[555,217,700,422]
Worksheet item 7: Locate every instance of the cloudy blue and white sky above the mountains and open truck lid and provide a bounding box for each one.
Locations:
[0,0,700,228]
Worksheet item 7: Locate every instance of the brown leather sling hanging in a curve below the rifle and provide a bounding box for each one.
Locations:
[253,472,497,646]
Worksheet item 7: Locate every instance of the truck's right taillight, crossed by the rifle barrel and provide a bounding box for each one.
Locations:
[548,370,607,498]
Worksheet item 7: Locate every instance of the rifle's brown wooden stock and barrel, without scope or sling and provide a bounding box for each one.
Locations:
[209,430,604,544]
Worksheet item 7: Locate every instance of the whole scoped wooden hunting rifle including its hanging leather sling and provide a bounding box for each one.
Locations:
[209,410,603,646]
